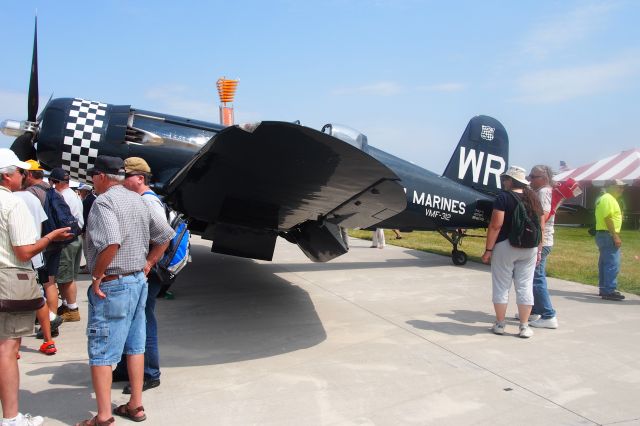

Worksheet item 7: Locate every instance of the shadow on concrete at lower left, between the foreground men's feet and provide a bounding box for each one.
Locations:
[20,362,96,425]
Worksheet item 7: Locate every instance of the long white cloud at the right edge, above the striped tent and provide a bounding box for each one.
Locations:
[516,55,640,103]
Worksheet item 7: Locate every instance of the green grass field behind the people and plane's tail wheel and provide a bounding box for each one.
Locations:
[349,226,640,295]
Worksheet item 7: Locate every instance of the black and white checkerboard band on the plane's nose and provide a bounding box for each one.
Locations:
[62,99,107,181]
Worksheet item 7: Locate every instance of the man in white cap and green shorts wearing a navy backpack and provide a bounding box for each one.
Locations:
[49,167,84,322]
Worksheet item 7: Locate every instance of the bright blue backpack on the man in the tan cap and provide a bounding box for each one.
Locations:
[142,191,191,282]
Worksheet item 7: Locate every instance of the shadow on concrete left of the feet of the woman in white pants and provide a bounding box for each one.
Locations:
[407,310,495,336]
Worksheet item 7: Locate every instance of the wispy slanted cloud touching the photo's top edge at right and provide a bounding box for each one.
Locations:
[523,2,616,59]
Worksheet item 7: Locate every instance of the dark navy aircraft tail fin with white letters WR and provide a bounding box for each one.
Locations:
[442,115,509,194]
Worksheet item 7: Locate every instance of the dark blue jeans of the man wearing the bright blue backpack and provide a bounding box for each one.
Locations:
[114,274,162,379]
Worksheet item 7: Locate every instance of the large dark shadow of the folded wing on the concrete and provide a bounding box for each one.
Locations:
[156,246,327,367]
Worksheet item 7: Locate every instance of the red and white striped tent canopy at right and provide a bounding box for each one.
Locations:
[553,148,640,186]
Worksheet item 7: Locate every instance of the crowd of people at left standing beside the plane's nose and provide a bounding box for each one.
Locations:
[0,149,175,426]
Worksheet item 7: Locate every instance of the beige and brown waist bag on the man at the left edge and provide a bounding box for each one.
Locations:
[0,268,44,312]
